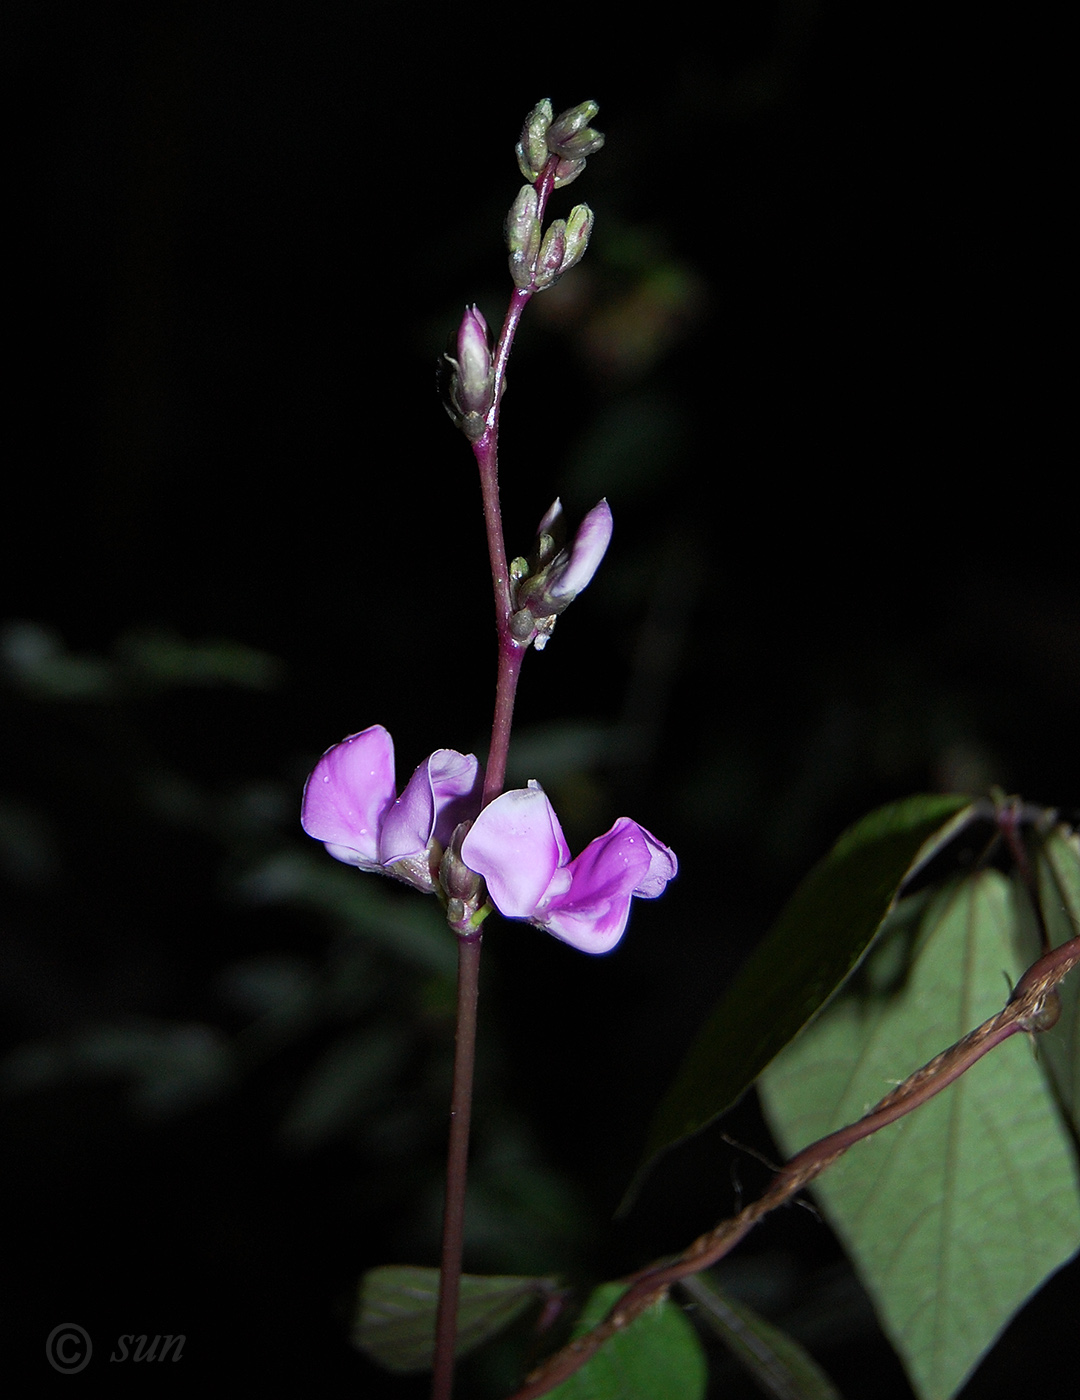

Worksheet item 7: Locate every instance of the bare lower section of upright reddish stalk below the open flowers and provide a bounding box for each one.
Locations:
[431,930,480,1400]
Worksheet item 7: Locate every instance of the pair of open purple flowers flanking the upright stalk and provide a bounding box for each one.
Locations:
[301,724,678,953]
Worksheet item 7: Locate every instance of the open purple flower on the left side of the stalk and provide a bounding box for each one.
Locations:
[300,724,483,893]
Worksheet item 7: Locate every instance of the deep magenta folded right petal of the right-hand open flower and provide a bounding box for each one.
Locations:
[539,816,649,953]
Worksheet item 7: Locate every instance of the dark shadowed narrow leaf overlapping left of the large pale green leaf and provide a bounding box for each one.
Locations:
[623,795,971,1205]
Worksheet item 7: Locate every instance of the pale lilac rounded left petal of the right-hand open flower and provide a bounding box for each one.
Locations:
[461,783,569,918]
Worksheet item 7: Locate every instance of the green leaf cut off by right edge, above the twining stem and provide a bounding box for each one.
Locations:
[1031,826,1080,1133]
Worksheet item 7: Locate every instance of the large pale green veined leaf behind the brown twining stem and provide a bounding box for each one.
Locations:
[759,871,1080,1400]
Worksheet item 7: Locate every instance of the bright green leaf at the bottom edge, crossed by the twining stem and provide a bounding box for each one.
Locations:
[551,1284,707,1400]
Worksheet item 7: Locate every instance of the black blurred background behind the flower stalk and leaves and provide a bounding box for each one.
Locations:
[0,0,1080,1397]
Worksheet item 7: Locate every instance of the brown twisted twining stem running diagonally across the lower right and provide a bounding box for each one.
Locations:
[508,937,1080,1400]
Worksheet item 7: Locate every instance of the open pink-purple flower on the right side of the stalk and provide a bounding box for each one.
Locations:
[461,783,678,953]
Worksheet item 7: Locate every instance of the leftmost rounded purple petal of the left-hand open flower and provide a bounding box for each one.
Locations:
[300,724,394,869]
